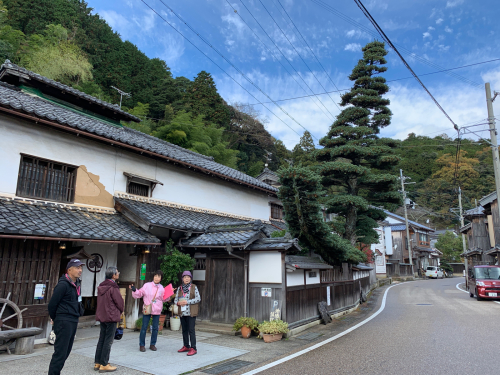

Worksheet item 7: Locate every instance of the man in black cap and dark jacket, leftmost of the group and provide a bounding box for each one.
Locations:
[48,259,83,375]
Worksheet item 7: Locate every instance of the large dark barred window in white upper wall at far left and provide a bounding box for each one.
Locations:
[16,155,77,203]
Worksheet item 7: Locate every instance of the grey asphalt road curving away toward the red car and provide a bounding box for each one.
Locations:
[252,278,500,375]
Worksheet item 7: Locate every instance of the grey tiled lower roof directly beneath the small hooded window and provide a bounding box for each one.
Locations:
[115,197,254,232]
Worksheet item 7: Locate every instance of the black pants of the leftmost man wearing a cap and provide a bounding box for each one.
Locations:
[49,319,78,375]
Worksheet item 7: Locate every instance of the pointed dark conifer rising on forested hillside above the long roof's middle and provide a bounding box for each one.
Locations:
[184,70,230,126]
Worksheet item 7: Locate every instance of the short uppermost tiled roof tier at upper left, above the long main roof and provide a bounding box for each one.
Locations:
[0,60,141,122]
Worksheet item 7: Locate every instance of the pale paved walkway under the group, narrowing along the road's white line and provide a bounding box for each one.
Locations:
[0,287,392,375]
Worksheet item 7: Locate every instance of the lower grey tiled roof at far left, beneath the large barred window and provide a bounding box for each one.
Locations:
[0,198,160,243]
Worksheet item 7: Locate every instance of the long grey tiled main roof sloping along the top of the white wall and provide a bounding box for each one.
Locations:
[0,70,278,192]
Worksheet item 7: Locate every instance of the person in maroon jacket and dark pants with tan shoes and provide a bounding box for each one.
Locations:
[94,267,125,372]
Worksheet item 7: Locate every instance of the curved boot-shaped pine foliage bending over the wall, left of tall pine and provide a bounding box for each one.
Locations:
[278,166,366,264]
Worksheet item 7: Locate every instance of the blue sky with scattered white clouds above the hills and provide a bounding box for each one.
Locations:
[87,0,500,149]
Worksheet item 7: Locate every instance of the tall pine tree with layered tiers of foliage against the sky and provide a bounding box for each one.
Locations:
[316,41,400,245]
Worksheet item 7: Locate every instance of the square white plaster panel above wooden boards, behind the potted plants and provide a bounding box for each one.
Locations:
[248,251,282,284]
